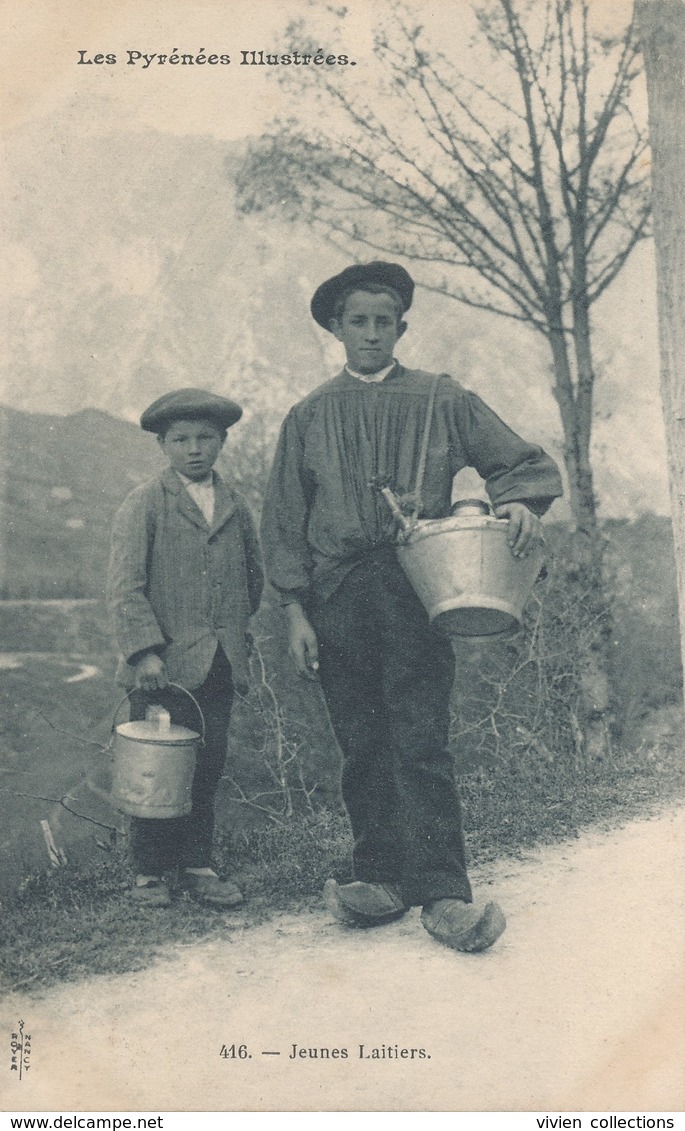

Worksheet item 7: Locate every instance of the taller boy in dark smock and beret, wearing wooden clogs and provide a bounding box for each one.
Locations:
[262,261,562,950]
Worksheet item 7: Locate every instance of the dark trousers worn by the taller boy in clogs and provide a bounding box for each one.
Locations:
[310,552,471,905]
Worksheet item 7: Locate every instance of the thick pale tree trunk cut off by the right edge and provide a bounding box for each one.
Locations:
[635,0,685,667]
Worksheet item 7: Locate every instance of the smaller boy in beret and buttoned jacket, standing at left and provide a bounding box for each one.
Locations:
[107,389,263,907]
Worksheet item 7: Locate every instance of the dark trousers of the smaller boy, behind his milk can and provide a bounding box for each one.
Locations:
[130,648,233,875]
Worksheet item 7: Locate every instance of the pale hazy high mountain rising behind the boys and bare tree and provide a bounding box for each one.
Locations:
[0,104,667,517]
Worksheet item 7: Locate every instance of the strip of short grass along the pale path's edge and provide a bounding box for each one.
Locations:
[0,743,683,992]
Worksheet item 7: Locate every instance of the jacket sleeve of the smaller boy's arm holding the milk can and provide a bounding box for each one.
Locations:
[107,490,166,674]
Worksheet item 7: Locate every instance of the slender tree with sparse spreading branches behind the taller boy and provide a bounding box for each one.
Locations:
[237,0,650,750]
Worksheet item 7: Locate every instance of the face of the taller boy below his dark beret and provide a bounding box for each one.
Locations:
[330,291,407,373]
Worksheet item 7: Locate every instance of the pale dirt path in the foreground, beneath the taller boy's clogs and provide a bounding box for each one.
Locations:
[0,810,685,1113]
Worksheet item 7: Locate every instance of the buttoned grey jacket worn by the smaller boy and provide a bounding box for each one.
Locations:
[107,468,263,690]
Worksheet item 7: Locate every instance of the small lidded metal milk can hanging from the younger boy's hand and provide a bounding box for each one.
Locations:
[112,683,205,818]
